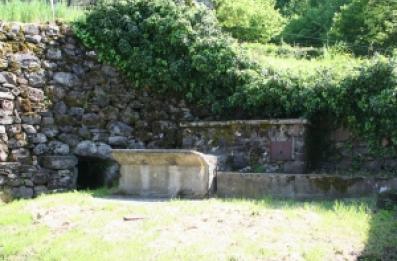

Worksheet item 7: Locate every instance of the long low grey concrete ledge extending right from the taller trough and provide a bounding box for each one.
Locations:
[217,172,397,199]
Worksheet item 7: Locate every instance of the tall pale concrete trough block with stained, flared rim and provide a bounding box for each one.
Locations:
[112,149,217,198]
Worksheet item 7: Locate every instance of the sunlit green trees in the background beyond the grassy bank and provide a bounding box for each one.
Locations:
[215,0,397,55]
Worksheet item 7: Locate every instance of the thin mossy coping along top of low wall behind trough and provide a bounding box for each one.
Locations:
[180,119,310,128]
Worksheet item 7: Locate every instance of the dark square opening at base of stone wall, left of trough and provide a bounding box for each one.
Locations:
[77,154,118,189]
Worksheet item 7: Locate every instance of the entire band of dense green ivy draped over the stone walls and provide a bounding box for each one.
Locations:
[75,0,397,152]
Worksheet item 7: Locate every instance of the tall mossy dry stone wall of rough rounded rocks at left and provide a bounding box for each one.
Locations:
[0,23,192,200]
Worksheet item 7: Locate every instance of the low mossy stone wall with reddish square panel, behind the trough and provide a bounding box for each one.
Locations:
[181,119,308,174]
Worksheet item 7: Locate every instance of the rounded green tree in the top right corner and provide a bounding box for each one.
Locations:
[331,0,397,54]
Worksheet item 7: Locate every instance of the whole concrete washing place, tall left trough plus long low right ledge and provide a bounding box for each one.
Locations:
[112,150,397,199]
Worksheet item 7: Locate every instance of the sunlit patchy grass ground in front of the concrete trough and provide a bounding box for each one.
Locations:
[0,191,397,260]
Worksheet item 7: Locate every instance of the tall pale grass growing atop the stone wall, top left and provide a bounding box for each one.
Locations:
[0,0,84,23]
